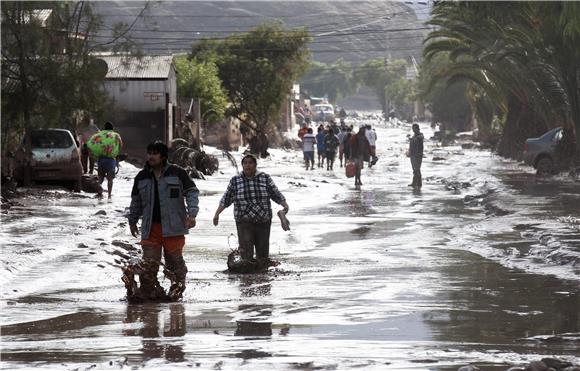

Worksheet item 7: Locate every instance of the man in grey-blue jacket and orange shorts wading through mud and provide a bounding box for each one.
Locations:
[129,141,199,301]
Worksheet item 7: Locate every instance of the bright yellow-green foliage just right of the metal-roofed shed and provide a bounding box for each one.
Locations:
[173,56,228,120]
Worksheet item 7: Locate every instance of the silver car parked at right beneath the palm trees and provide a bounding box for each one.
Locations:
[524,127,563,175]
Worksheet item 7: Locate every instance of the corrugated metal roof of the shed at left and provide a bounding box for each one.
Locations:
[98,55,173,79]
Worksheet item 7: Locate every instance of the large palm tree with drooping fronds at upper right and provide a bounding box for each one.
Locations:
[424,2,580,163]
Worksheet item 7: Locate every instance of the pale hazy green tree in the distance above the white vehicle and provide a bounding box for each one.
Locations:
[300,60,358,103]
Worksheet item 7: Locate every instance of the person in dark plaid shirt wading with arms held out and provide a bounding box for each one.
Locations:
[213,155,288,264]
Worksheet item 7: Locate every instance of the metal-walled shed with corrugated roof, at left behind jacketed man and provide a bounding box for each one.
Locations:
[98,55,177,157]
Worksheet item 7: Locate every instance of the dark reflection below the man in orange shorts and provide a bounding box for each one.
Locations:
[123,303,186,362]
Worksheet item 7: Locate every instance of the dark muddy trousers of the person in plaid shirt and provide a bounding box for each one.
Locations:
[236,221,272,260]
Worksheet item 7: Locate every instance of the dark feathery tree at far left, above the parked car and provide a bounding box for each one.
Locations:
[1,1,147,148]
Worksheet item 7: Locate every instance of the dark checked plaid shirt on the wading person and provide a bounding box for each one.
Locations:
[220,172,286,223]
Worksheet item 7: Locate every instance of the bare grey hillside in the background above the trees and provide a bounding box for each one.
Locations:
[92,1,427,64]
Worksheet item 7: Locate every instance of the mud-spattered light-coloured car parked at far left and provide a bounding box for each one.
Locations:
[14,129,83,192]
